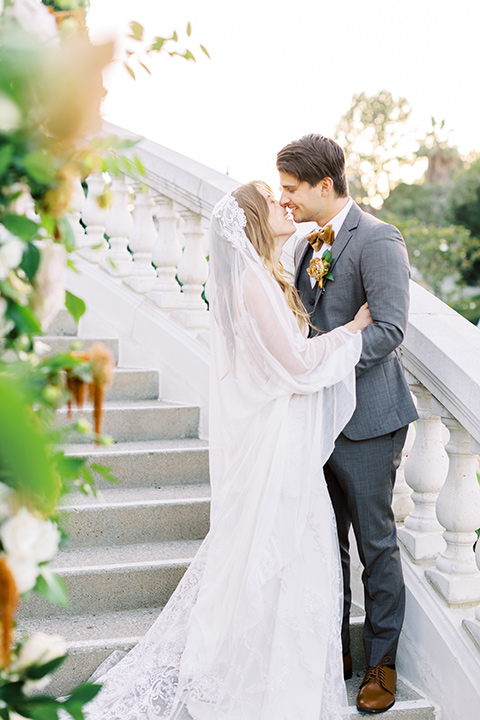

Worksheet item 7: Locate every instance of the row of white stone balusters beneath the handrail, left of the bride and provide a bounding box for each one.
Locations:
[79,174,208,330]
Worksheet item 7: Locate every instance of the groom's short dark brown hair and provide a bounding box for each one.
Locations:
[277,133,348,197]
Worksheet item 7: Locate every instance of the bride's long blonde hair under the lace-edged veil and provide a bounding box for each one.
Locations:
[232,180,313,331]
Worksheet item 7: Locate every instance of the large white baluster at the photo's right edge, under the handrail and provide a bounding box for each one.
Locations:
[426,411,480,605]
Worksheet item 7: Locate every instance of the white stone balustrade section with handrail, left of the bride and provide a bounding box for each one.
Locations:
[73,123,237,331]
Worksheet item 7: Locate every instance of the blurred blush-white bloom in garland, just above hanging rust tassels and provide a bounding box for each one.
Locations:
[33,241,67,330]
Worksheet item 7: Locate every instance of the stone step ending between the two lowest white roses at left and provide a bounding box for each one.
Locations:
[19,540,200,623]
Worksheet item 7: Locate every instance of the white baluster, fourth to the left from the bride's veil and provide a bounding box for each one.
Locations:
[102,177,133,277]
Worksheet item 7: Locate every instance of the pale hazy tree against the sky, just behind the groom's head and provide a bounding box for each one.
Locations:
[336,90,414,207]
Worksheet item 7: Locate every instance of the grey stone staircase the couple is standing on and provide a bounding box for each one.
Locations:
[19,312,437,720]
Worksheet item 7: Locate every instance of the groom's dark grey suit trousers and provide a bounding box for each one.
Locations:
[324,427,408,666]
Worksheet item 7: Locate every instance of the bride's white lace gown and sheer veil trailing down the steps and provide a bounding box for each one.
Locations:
[83,195,362,720]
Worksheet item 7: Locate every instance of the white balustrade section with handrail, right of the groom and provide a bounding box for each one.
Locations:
[394,284,480,650]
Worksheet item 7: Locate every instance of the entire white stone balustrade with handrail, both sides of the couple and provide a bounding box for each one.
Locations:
[75,121,480,651]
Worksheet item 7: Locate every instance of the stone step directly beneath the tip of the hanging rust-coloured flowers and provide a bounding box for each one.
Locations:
[66,438,209,488]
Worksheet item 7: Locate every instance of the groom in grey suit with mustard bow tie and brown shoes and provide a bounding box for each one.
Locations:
[277,134,418,713]
